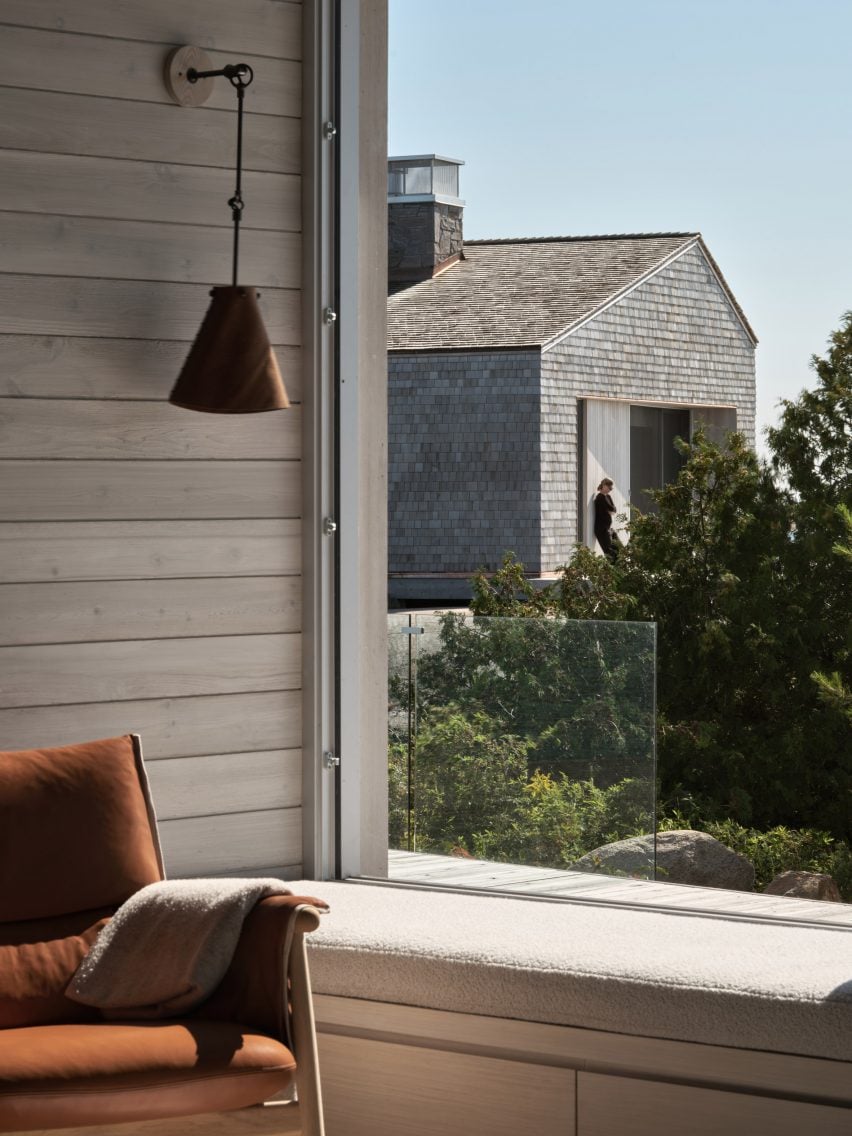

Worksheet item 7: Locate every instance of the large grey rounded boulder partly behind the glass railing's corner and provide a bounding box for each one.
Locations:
[571,828,754,892]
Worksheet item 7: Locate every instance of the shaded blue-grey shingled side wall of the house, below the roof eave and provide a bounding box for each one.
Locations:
[387,349,542,575]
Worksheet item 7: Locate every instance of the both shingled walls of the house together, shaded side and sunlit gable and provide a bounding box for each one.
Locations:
[389,245,754,590]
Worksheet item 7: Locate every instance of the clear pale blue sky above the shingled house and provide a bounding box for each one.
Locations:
[389,0,852,449]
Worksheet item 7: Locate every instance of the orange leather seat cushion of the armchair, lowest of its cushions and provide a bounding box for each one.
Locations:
[0,1021,295,1131]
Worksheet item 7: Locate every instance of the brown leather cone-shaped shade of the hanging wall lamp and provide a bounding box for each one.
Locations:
[168,286,290,415]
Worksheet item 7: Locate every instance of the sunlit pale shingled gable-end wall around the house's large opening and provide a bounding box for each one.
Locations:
[540,245,755,571]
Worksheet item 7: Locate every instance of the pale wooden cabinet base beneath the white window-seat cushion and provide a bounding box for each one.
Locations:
[315,994,852,1136]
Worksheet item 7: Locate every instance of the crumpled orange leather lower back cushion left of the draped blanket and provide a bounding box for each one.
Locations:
[0,910,110,1029]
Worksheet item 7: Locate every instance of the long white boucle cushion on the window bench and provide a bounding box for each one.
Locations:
[289,880,852,1061]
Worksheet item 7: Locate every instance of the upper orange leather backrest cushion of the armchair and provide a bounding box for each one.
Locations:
[0,736,161,922]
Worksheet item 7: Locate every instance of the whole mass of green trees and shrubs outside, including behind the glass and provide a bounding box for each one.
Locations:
[391,314,852,867]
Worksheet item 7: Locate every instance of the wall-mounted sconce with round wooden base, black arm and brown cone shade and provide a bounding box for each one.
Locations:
[165,47,290,415]
